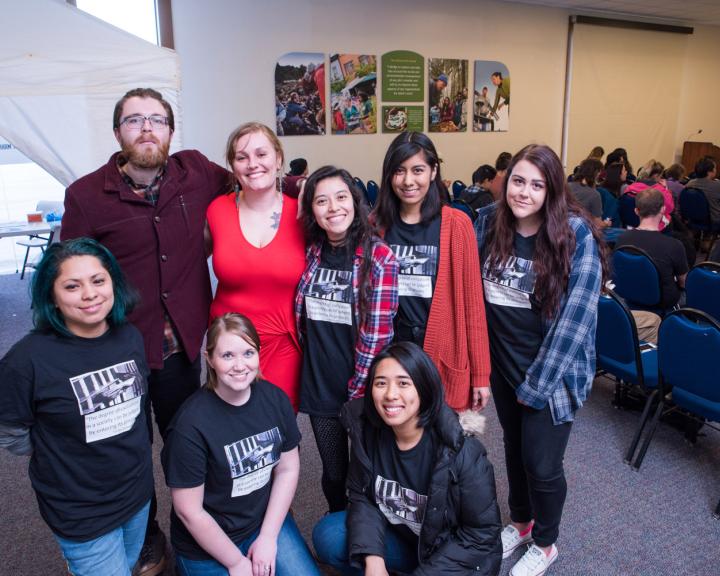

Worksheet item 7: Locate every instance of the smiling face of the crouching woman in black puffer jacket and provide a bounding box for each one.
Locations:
[372,358,420,435]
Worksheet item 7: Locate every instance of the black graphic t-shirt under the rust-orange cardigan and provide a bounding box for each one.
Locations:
[385,215,440,346]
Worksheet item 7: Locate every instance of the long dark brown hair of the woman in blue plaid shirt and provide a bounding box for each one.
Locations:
[487,144,608,318]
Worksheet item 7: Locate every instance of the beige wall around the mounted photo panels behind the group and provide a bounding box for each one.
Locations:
[173,0,567,181]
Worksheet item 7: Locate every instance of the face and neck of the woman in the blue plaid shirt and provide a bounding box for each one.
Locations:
[506,160,547,236]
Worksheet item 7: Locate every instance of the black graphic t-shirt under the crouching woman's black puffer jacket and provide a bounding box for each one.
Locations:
[366,427,435,546]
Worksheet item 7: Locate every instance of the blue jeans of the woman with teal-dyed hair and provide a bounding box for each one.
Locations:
[54,501,150,576]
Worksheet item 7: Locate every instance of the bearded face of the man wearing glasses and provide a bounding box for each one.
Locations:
[115,96,173,169]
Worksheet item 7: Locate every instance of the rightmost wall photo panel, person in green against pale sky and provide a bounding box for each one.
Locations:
[473,60,510,132]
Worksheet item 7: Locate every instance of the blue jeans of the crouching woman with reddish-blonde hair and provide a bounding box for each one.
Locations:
[175,514,320,576]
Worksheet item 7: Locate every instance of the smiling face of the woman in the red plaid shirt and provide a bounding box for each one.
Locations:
[312,176,355,244]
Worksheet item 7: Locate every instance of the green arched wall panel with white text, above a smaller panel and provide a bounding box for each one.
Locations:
[380,50,425,102]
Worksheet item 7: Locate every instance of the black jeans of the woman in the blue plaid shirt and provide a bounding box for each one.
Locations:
[490,373,572,547]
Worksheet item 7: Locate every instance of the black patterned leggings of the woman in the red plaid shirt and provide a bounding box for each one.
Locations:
[310,416,350,512]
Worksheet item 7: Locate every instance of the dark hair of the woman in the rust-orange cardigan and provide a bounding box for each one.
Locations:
[373,132,450,230]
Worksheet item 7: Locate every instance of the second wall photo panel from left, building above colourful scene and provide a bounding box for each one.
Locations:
[330,54,377,134]
